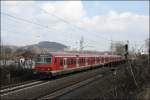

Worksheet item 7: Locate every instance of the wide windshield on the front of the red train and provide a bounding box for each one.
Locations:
[36,55,52,65]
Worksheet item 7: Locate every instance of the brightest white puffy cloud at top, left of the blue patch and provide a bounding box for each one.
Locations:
[42,1,86,20]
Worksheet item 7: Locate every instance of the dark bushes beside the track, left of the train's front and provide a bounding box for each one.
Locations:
[0,65,33,85]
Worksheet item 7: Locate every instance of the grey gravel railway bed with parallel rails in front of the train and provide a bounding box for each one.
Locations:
[1,63,125,100]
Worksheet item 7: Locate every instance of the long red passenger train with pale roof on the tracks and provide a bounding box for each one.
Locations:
[33,52,124,76]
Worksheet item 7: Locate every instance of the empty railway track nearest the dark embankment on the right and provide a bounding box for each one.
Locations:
[36,68,124,100]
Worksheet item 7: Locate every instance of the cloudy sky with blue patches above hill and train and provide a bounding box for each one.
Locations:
[1,1,149,51]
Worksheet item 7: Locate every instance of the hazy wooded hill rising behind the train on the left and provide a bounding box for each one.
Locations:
[0,41,67,59]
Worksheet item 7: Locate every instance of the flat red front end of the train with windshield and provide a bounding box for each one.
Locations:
[33,54,52,78]
